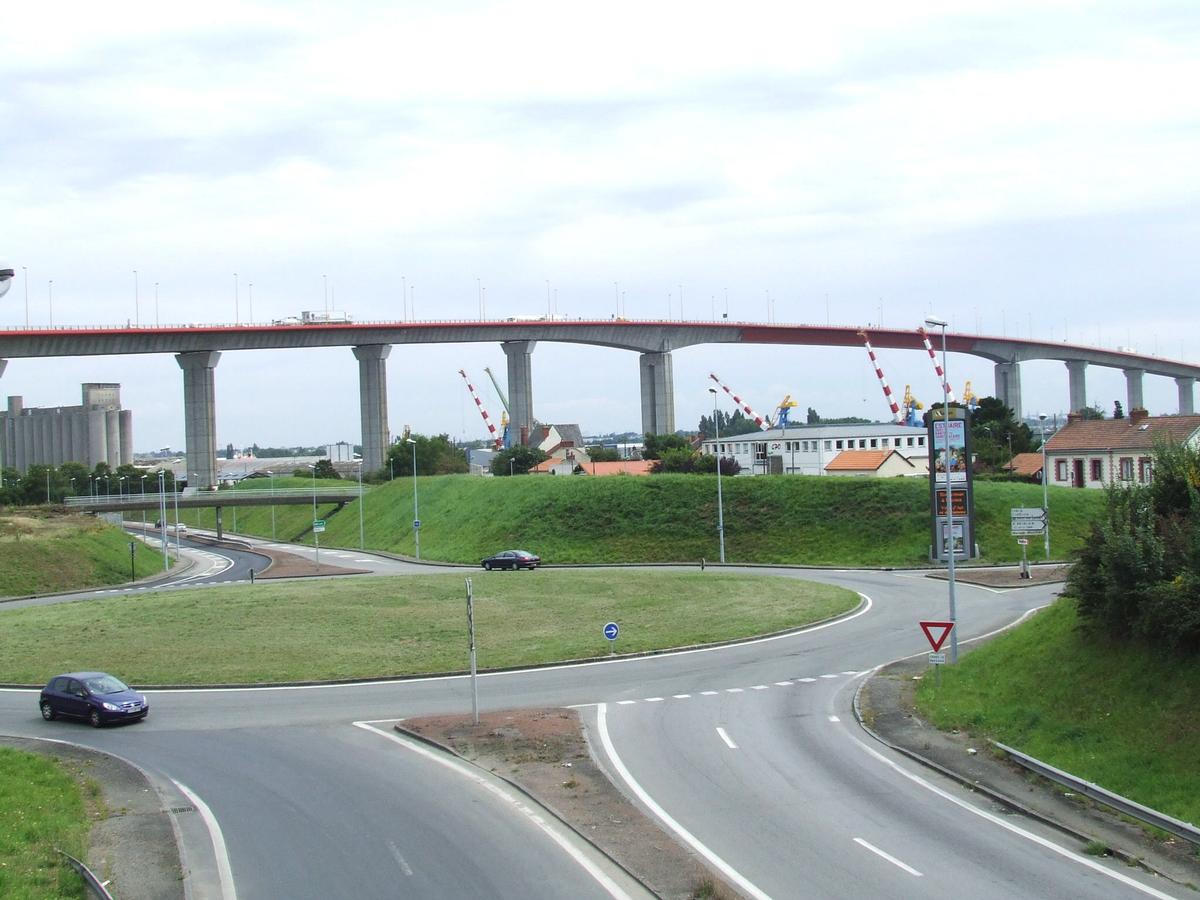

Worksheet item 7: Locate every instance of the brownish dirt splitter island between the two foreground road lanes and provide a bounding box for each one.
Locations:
[397,709,738,900]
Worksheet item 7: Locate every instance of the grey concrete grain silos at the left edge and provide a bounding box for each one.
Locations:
[0,384,133,473]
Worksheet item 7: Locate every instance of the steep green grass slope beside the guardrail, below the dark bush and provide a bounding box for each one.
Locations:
[917,600,1200,822]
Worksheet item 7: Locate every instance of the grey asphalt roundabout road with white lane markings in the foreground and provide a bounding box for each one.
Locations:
[0,561,1188,900]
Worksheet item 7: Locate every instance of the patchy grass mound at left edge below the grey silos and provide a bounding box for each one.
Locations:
[0,509,162,596]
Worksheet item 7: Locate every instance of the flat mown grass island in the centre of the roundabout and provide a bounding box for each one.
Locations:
[0,570,859,685]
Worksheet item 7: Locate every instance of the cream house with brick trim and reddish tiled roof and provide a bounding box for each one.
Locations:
[1046,409,1200,487]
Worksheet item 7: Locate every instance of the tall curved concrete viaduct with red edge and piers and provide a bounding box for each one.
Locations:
[0,319,1200,485]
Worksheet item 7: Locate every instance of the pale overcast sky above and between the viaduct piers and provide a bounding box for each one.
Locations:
[0,0,1200,450]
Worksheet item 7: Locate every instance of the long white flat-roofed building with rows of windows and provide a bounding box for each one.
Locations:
[701,422,929,475]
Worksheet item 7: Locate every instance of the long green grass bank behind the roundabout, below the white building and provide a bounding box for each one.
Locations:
[192,475,1103,566]
